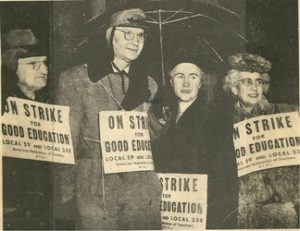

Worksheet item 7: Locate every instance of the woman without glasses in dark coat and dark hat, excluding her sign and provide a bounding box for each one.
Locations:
[154,48,237,229]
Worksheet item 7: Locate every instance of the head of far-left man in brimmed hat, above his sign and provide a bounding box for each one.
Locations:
[2,29,49,105]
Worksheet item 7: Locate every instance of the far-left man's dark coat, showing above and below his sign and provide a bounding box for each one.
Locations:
[2,82,53,229]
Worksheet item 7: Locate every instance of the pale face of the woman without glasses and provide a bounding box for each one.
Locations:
[170,63,202,102]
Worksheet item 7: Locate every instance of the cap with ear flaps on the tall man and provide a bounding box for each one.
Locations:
[106,8,149,43]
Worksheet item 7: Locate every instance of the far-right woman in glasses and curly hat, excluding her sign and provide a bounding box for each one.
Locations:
[223,53,299,228]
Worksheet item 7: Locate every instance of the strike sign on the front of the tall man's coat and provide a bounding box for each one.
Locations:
[99,111,154,174]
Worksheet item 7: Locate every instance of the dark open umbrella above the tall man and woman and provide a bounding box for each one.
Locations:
[77,1,246,86]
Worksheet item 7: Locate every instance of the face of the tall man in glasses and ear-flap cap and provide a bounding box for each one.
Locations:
[112,27,145,63]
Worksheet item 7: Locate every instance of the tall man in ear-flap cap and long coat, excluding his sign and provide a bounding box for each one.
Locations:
[57,9,161,230]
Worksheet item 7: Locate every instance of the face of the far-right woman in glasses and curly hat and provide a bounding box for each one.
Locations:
[232,72,263,108]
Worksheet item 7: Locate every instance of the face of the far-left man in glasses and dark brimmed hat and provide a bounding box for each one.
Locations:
[16,56,48,90]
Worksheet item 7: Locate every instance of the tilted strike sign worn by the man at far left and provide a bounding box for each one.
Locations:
[1,97,74,164]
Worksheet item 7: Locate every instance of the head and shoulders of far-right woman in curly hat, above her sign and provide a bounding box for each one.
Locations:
[223,53,297,122]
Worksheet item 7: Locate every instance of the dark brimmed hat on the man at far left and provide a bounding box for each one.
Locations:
[1,29,46,70]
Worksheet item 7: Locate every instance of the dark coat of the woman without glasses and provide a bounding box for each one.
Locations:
[154,93,237,229]
